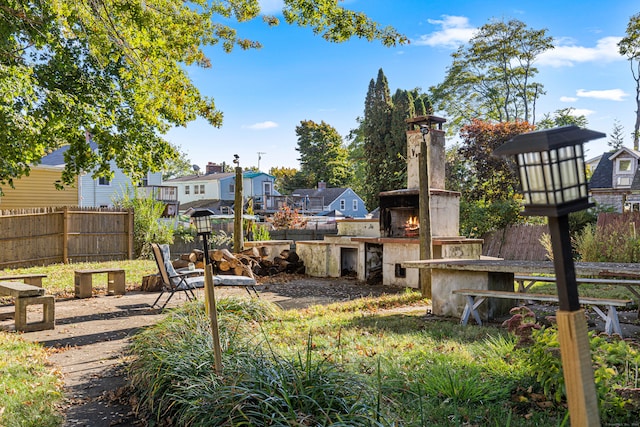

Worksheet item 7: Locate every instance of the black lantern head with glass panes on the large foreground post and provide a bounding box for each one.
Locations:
[494,125,606,217]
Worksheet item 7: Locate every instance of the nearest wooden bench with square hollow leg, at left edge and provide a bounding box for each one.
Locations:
[0,281,55,332]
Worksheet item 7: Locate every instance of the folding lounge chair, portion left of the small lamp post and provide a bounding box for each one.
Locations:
[151,243,204,311]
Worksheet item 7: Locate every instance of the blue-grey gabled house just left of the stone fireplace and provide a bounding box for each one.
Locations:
[291,182,367,218]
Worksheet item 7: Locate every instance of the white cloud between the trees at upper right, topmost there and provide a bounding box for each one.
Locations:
[536,37,625,67]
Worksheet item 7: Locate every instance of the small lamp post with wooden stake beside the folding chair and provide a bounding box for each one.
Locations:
[191,209,222,375]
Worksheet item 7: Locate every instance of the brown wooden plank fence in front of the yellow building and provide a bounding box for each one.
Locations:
[0,207,133,269]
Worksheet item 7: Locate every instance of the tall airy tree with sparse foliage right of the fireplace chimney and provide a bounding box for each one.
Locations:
[430,19,553,130]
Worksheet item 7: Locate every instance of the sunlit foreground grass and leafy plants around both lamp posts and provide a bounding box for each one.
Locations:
[130,293,640,426]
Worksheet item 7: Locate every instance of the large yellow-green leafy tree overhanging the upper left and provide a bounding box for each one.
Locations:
[0,0,407,191]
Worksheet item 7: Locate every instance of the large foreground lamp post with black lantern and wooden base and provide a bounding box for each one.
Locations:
[494,126,606,426]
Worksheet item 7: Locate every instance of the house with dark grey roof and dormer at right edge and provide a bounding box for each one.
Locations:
[589,147,640,212]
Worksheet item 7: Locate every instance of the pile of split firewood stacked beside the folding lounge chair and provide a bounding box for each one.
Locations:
[173,246,305,277]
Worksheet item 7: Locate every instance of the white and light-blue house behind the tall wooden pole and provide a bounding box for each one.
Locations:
[165,162,279,215]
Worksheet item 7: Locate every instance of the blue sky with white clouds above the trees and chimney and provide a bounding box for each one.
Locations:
[166,0,640,172]
